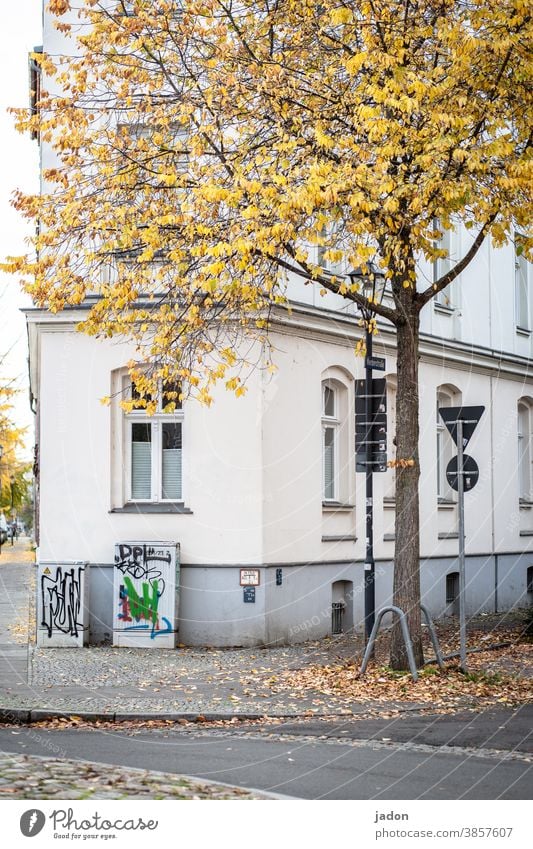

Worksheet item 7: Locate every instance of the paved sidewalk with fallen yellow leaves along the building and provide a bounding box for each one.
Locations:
[0,541,533,722]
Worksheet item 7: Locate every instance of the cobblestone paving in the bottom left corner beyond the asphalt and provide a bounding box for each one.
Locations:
[0,754,274,800]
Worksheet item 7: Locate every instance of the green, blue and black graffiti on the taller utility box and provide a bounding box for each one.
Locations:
[115,543,175,640]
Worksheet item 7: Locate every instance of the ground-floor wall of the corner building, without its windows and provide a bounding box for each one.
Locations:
[29,296,533,645]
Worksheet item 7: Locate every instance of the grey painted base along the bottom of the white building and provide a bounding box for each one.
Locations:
[89,553,533,647]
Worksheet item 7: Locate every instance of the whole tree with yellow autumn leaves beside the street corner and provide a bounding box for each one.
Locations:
[5,0,533,668]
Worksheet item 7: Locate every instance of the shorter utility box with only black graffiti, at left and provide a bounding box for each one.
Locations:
[37,560,89,648]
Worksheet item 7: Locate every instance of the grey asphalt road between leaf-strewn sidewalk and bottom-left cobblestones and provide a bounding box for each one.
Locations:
[0,708,533,800]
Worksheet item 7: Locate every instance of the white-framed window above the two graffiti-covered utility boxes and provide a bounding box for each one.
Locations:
[124,384,183,503]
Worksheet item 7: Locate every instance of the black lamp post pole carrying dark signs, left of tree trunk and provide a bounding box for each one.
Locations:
[365,327,376,643]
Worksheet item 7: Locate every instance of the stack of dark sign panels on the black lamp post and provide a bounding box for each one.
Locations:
[355,378,387,472]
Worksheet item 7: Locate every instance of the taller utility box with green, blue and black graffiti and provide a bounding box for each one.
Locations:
[113,541,180,649]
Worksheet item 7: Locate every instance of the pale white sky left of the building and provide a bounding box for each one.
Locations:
[0,0,42,457]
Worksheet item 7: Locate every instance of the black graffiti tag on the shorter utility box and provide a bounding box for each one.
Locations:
[41,566,84,637]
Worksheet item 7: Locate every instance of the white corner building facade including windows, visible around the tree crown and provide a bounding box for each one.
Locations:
[26,1,533,646]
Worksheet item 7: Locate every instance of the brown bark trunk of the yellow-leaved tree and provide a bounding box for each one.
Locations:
[390,302,424,669]
